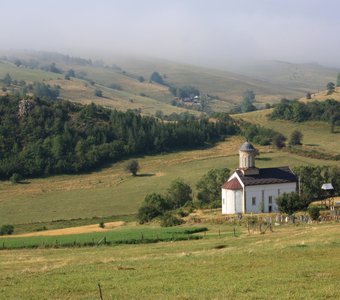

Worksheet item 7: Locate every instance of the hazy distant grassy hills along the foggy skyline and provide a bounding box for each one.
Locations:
[0,52,338,114]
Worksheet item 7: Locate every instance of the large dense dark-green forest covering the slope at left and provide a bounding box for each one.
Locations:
[0,96,238,179]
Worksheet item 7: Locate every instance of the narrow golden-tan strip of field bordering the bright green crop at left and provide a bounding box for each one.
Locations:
[6,221,124,237]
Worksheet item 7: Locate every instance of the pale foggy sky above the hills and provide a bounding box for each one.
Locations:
[0,0,340,67]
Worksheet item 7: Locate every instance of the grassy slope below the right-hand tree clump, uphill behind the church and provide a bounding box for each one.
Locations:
[233,109,340,154]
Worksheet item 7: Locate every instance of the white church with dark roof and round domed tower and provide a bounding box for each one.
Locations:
[222,142,297,214]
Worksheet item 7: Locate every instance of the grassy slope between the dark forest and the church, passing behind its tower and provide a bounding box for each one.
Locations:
[0,137,338,224]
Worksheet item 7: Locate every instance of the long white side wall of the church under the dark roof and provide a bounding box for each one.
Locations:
[245,182,296,213]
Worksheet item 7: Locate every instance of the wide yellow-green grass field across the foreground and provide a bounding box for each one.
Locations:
[0,224,340,299]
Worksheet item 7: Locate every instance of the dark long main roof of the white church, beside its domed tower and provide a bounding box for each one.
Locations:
[236,167,297,186]
